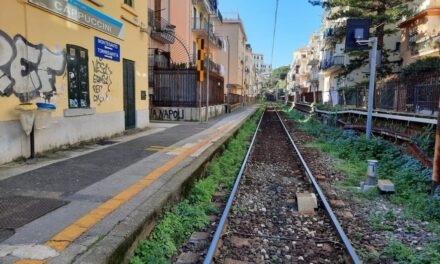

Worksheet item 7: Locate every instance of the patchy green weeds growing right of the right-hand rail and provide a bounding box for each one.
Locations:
[286,110,440,263]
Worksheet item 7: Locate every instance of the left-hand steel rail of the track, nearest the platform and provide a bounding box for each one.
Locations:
[203,110,266,264]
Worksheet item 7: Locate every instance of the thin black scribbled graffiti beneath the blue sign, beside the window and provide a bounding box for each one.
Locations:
[93,58,113,105]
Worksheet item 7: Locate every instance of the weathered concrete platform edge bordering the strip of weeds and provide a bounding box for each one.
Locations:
[64,108,258,264]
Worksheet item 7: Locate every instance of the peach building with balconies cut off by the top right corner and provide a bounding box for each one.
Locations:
[399,0,440,66]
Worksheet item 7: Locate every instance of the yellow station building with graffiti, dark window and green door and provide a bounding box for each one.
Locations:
[0,0,149,163]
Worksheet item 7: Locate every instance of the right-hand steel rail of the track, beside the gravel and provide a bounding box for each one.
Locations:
[275,110,362,264]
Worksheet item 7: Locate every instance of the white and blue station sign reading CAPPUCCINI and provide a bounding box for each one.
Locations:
[28,0,124,39]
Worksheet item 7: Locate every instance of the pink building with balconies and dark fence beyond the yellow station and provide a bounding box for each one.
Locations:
[150,0,225,121]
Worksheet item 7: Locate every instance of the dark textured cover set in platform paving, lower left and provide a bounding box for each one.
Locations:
[0,196,68,230]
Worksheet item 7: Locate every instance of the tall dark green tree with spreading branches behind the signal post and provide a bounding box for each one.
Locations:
[309,0,412,78]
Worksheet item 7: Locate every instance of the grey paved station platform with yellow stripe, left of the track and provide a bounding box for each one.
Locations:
[0,107,256,263]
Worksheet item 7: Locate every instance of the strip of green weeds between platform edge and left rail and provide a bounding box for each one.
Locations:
[130,109,263,264]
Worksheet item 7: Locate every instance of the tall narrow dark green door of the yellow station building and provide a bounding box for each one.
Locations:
[123,59,136,129]
